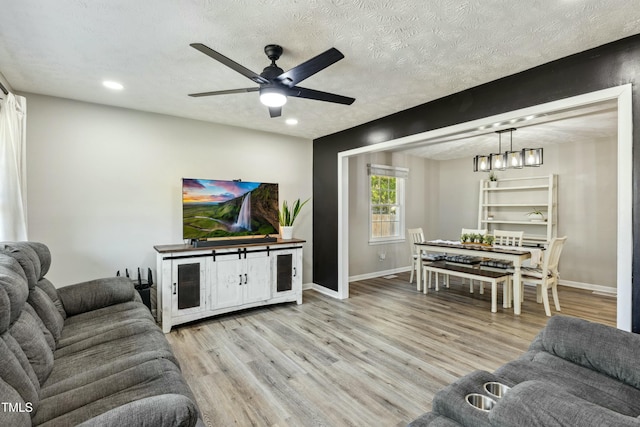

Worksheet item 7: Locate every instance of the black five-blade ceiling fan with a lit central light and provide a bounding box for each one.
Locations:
[189,43,355,117]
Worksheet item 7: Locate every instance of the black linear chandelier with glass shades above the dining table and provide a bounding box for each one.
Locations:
[473,128,542,172]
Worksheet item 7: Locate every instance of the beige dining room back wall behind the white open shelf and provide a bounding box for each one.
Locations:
[439,135,617,288]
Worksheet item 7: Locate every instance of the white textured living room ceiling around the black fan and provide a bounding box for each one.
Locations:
[0,0,640,140]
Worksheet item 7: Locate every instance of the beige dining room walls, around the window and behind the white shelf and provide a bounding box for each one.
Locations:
[349,131,617,288]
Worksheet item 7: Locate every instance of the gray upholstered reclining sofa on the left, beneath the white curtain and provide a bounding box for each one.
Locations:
[0,242,203,427]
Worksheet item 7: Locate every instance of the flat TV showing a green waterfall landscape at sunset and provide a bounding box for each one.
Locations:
[182,178,278,239]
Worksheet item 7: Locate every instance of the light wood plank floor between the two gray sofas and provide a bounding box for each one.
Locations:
[167,273,616,426]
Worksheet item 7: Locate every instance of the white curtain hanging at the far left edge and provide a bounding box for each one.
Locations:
[0,93,27,241]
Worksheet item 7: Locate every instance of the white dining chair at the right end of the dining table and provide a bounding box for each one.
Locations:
[507,236,567,316]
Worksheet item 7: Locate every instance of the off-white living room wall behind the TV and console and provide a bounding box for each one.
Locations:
[25,94,313,286]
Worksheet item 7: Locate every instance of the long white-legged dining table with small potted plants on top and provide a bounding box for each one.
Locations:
[414,241,532,315]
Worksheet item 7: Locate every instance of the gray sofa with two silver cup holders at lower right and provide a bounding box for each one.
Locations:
[409,316,640,427]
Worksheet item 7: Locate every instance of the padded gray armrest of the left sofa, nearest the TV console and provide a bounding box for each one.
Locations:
[58,277,135,316]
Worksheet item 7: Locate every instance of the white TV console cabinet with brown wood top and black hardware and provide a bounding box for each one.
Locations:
[154,239,305,333]
